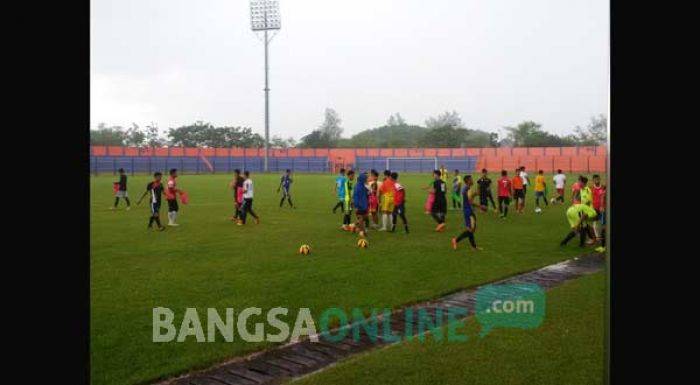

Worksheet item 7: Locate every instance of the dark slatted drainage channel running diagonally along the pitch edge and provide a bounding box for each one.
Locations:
[159,253,605,385]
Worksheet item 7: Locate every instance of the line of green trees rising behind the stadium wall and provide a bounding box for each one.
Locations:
[90,108,607,148]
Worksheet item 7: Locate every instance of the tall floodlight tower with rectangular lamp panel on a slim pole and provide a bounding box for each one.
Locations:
[250,0,282,172]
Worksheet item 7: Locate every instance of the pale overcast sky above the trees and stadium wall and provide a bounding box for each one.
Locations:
[91,0,609,139]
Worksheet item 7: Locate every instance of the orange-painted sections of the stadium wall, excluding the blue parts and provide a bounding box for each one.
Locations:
[90,146,607,172]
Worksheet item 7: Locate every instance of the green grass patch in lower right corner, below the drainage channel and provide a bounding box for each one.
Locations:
[294,273,605,385]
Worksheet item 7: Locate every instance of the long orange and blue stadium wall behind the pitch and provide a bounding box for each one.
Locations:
[90,146,607,174]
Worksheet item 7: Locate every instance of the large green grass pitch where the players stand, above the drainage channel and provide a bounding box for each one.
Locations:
[90,174,602,385]
